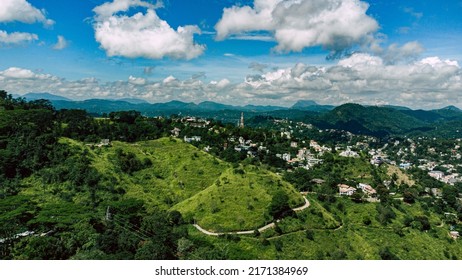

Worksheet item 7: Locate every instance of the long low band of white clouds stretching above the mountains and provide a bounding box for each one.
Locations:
[0,53,462,108]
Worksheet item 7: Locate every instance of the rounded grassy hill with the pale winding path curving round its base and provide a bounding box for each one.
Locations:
[172,166,304,232]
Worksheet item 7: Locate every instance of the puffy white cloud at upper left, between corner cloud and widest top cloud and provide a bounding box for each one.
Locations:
[93,0,205,60]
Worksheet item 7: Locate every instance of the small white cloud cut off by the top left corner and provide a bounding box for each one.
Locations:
[0,0,54,26]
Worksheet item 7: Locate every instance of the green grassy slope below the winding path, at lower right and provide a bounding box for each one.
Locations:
[185,196,462,260]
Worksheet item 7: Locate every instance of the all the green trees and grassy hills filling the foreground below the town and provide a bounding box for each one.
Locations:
[0,91,462,259]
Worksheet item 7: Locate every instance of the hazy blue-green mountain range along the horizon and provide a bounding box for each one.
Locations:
[22,93,462,138]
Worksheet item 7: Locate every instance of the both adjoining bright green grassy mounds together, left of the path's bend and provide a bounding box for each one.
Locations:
[23,138,303,231]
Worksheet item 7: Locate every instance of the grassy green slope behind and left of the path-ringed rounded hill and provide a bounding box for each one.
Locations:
[89,138,229,209]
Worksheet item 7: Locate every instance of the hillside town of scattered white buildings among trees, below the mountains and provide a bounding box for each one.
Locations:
[171,114,462,206]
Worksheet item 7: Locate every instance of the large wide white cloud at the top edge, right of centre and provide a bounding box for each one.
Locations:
[215,0,379,52]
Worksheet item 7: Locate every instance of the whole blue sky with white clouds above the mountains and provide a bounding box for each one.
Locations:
[0,0,462,109]
